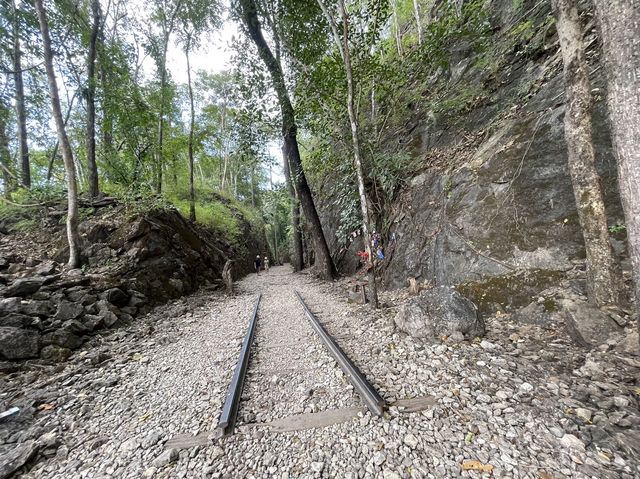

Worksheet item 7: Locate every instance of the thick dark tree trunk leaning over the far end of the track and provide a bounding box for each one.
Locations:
[239,0,336,279]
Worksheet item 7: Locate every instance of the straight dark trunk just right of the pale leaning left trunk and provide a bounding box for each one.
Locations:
[87,0,100,198]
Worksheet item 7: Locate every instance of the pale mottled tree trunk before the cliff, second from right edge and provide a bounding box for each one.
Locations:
[553,0,622,306]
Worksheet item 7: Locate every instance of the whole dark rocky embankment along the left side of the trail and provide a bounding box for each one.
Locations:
[0,202,262,369]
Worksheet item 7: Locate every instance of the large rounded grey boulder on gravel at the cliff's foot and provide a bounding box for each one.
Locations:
[395,286,485,340]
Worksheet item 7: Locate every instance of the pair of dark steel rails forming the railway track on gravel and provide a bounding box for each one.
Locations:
[213,291,386,438]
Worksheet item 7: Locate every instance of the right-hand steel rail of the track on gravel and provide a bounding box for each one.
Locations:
[295,291,386,416]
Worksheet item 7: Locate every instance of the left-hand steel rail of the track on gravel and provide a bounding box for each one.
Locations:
[213,294,262,438]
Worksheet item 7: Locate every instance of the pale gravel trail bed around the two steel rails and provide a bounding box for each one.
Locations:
[0,267,640,479]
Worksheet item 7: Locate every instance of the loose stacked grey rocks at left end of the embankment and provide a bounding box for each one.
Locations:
[0,260,149,367]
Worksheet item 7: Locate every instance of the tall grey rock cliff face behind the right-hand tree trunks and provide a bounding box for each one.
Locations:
[320,0,624,312]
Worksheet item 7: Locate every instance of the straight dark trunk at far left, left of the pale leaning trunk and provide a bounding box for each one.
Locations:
[12,0,31,188]
